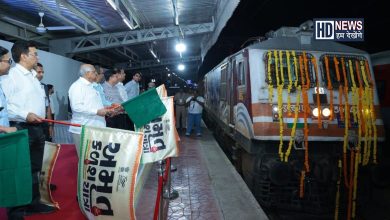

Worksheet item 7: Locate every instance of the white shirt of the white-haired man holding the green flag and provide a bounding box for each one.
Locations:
[69,77,106,134]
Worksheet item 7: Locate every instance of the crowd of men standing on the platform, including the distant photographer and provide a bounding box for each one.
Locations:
[0,41,204,220]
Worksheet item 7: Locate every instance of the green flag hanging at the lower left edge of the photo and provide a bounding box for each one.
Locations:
[0,130,32,207]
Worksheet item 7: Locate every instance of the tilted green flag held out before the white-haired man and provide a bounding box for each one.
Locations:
[122,88,167,128]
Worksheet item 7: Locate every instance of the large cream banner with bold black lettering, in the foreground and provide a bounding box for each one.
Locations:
[77,126,143,220]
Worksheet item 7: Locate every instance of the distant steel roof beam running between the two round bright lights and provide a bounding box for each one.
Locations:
[125,56,201,70]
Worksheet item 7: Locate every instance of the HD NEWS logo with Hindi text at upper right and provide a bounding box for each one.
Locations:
[314,18,364,41]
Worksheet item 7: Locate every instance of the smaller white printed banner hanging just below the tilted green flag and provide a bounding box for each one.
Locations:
[136,97,179,164]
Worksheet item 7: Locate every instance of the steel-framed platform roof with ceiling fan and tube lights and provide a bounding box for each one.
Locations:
[0,0,239,82]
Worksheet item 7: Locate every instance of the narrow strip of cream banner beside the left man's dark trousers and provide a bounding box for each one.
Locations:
[39,142,61,209]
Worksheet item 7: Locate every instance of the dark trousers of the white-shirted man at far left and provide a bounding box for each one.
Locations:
[10,121,45,203]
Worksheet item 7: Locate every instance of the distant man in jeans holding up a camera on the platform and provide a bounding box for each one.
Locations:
[186,90,204,137]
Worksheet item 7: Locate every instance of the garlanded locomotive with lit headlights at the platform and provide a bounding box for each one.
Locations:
[203,23,385,218]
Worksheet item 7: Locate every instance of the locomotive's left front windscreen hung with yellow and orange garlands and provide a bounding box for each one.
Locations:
[264,50,315,88]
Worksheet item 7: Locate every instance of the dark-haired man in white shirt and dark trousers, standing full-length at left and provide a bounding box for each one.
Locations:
[1,41,55,216]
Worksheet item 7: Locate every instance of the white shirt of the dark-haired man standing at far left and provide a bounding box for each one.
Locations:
[1,64,46,122]
